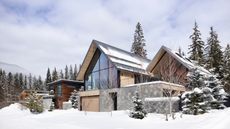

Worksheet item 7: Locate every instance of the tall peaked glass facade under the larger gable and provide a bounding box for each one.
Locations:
[85,50,118,90]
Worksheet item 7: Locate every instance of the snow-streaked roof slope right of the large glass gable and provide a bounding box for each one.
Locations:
[94,40,150,73]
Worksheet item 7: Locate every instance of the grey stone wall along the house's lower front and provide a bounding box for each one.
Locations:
[100,82,184,113]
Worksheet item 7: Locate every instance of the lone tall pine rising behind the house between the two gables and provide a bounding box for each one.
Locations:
[131,22,147,58]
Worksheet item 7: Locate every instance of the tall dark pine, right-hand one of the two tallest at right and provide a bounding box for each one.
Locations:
[205,27,223,79]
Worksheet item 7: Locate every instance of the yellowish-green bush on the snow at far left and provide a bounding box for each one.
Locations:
[26,91,43,113]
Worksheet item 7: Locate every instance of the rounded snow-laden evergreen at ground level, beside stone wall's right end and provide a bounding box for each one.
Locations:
[181,88,207,115]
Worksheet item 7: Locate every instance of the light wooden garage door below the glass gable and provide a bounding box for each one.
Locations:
[81,96,99,112]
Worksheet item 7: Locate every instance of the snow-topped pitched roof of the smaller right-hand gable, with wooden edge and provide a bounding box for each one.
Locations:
[146,46,211,74]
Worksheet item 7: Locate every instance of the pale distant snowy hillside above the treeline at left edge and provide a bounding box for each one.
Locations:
[0,61,29,74]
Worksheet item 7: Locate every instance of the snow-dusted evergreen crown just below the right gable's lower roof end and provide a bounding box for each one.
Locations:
[187,68,205,89]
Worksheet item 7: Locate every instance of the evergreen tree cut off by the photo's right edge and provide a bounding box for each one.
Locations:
[223,44,230,93]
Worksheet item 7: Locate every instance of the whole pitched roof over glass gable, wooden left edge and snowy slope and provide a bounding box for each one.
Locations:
[77,40,150,80]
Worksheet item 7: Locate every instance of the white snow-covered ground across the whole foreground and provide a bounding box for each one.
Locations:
[0,104,230,129]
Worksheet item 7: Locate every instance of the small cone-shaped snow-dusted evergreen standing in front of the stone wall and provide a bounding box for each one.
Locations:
[129,92,147,119]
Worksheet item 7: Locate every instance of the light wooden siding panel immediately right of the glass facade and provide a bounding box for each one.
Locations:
[120,71,135,87]
